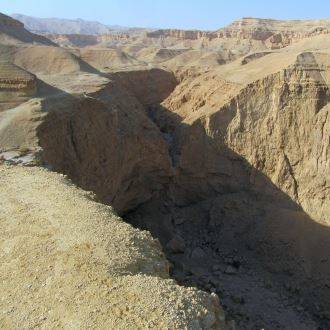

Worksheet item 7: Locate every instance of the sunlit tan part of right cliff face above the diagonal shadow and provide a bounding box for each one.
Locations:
[164,53,329,222]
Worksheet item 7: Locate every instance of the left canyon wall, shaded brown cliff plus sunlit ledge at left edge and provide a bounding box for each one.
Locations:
[0,69,176,213]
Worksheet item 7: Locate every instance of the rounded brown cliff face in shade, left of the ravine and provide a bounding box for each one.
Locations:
[38,93,170,214]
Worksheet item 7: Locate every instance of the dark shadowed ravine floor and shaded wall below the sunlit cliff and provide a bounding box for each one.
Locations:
[122,104,330,329]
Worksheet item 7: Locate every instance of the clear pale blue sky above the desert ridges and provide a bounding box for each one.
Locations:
[0,0,330,30]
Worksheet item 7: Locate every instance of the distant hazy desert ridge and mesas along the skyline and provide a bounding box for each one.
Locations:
[10,15,330,54]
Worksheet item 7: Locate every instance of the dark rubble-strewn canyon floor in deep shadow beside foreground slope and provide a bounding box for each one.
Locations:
[124,197,327,329]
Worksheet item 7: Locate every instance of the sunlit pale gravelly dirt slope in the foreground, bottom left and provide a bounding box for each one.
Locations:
[0,165,224,329]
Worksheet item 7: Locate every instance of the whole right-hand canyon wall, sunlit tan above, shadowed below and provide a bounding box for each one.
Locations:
[153,43,330,324]
